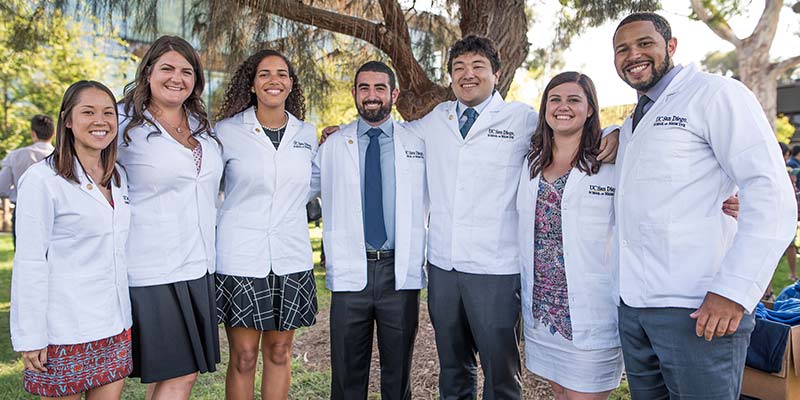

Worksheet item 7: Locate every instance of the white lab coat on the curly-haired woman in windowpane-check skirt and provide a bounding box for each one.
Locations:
[215,107,317,278]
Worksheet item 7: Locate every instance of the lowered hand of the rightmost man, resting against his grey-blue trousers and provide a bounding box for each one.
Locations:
[689,292,744,342]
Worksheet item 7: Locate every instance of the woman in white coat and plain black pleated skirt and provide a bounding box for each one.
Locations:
[119,36,222,399]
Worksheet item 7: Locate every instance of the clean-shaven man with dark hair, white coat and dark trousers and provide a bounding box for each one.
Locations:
[407,36,537,400]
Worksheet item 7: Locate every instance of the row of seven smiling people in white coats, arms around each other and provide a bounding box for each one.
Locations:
[11,13,796,400]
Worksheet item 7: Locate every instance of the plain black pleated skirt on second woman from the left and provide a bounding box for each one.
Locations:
[130,274,220,383]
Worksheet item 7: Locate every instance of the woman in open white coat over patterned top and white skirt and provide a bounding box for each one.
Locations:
[517,72,622,400]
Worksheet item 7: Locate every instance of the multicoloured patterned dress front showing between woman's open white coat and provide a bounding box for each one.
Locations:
[533,171,572,340]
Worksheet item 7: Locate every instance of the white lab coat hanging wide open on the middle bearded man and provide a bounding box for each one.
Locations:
[315,122,428,292]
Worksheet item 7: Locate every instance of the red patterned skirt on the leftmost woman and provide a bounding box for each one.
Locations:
[22,329,133,397]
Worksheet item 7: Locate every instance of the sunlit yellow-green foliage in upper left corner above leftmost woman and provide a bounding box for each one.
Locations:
[0,0,131,161]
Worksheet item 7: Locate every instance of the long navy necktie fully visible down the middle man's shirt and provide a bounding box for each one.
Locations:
[364,128,386,250]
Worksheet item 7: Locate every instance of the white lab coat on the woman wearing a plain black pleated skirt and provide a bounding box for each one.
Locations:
[118,106,222,287]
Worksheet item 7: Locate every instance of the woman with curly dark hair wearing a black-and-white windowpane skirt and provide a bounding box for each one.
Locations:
[216,50,317,399]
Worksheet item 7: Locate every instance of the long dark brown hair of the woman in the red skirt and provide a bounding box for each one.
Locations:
[48,81,120,187]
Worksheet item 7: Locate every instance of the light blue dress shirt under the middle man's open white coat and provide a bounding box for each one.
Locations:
[356,117,396,250]
